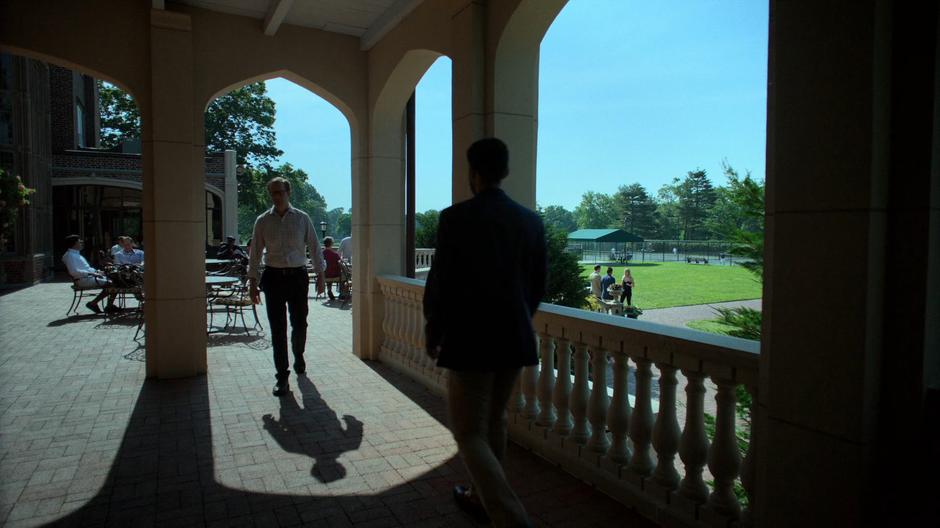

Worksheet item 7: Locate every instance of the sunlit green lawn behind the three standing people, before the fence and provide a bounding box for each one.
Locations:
[583,262,761,310]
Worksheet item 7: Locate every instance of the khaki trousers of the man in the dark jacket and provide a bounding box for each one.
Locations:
[447,369,529,526]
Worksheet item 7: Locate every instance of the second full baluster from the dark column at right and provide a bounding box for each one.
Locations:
[679,370,708,504]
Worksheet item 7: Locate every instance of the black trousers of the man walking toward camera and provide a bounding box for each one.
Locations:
[261,267,310,382]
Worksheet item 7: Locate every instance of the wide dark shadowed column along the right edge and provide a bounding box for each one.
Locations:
[755,0,937,526]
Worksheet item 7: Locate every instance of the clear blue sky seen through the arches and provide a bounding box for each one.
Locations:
[268,0,768,211]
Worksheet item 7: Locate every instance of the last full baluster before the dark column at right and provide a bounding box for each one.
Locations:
[708,379,741,517]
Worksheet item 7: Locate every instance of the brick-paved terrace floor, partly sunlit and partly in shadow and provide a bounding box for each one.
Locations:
[0,283,649,528]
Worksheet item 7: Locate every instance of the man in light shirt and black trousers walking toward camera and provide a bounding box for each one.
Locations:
[248,178,324,396]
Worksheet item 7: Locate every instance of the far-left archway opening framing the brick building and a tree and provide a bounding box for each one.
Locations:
[0,52,143,284]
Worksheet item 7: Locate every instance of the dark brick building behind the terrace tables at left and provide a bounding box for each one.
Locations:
[0,54,238,285]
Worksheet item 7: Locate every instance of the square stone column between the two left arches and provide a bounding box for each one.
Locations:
[142,10,206,378]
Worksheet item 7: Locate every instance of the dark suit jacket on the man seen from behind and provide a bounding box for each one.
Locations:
[424,189,547,371]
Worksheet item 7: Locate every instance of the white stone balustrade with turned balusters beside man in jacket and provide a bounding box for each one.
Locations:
[379,276,759,526]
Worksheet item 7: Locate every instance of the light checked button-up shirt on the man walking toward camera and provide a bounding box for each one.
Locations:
[248,206,324,279]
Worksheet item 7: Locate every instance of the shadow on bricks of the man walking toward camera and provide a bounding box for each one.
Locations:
[262,376,362,483]
